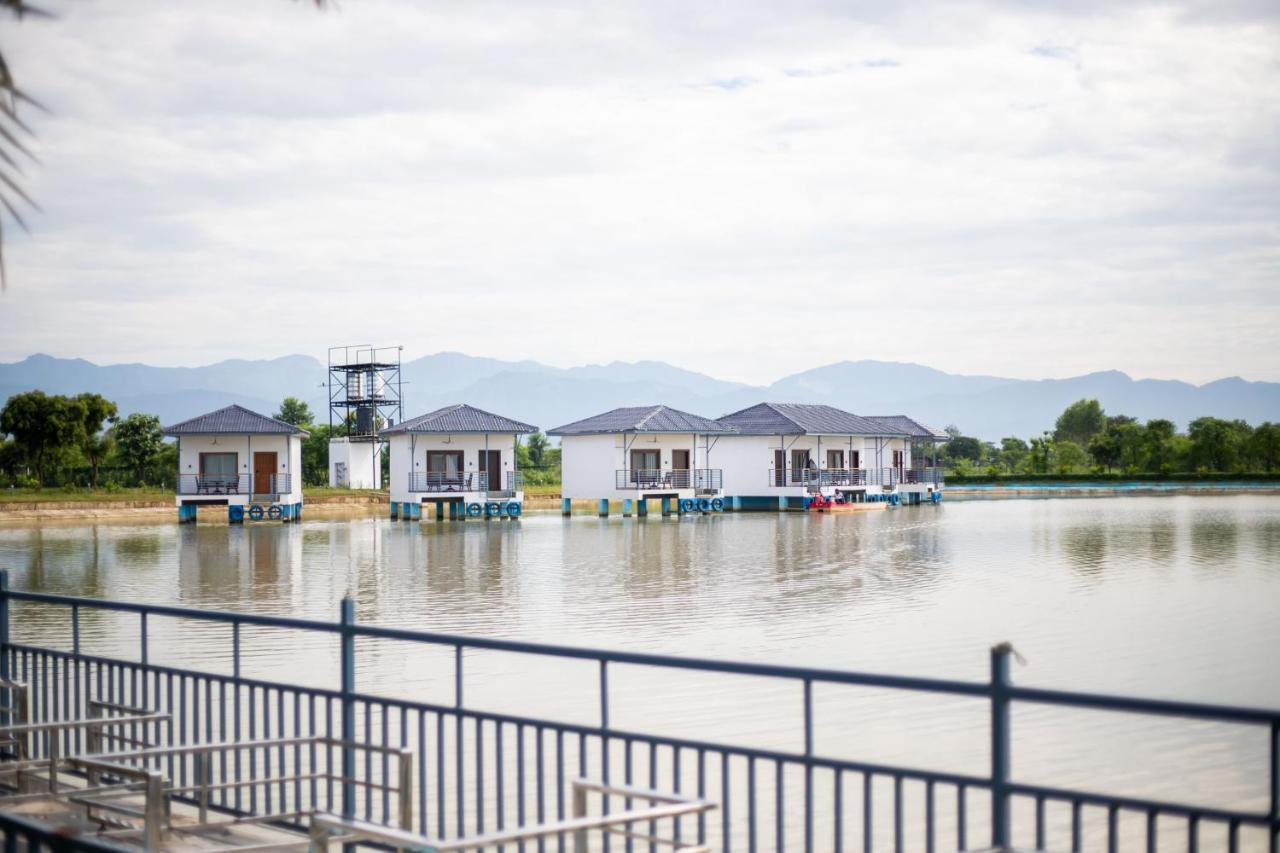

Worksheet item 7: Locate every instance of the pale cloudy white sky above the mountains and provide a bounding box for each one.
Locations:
[0,0,1280,383]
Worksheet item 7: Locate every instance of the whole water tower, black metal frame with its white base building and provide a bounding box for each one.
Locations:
[329,345,403,489]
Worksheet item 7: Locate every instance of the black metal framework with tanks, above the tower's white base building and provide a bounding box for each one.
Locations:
[329,345,404,442]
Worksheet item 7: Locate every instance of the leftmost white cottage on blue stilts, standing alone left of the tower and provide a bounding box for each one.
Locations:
[164,406,307,524]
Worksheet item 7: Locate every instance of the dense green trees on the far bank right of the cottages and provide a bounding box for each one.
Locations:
[941,400,1280,476]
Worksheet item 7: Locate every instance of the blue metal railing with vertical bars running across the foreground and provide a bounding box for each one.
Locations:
[0,563,1280,853]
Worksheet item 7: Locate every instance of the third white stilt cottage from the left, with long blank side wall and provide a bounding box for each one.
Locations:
[547,406,733,515]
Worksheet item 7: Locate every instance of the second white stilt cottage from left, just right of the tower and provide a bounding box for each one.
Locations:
[380,403,538,520]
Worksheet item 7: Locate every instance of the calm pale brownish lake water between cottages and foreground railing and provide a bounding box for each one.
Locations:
[0,496,1280,840]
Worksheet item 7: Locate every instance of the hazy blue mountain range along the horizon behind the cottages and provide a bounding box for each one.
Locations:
[0,352,1280,439]
